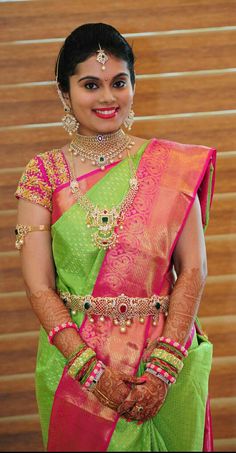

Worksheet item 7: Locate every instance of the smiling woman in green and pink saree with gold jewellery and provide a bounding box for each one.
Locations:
[16,23,215,451]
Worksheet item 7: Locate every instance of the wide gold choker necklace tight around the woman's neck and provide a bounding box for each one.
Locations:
[69,129,134,170]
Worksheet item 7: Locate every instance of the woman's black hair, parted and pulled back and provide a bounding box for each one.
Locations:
[55,23,135,93]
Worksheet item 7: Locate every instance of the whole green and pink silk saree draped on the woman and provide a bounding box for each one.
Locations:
[36,139,217,451]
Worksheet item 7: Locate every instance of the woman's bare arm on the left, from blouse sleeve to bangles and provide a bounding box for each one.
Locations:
[17,199,82,358]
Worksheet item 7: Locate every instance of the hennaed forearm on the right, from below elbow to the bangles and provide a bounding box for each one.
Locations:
[163,268,206,345]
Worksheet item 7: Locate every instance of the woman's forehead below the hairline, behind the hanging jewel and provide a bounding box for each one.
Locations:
[75,54,129,77]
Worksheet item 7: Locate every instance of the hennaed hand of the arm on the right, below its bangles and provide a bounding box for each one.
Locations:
[117,373,168,421]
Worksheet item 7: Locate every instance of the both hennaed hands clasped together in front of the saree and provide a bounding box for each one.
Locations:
[93,367,168,421]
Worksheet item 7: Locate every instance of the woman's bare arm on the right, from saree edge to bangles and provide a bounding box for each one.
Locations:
[163,192,207,345]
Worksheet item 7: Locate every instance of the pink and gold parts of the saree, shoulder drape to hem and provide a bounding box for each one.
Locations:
[48,139,215,451]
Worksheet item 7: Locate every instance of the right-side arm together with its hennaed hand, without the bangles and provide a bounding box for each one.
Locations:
[119,193,207,421]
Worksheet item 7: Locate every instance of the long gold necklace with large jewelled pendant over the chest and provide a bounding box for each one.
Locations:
[70,150,138,250]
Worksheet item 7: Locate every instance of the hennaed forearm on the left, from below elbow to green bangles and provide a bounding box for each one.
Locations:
[27,288,83,358]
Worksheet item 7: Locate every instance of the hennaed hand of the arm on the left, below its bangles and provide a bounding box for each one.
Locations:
[93,366,142,411]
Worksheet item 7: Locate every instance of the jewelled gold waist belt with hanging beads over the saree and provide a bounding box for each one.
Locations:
[59,292,169,332]
